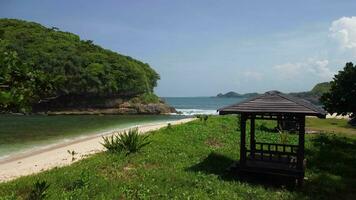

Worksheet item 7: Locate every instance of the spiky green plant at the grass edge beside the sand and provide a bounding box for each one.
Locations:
[102,128,150,155]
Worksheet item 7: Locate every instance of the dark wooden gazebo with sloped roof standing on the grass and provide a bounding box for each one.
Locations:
[218,91,326,184]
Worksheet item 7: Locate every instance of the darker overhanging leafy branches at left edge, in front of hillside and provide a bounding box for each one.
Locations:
[0,49,51,112]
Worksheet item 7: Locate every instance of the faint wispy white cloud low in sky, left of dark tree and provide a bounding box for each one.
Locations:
[273,59,334,80]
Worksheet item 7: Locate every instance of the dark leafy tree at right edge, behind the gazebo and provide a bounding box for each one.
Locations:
[320,62,356,125]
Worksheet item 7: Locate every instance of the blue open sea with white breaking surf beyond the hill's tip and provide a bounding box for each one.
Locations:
[163,97,245,115]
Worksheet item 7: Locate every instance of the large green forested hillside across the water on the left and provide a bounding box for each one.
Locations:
[0,19,159,112]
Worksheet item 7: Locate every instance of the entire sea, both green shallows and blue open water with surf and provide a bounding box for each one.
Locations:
[0,97,243,160]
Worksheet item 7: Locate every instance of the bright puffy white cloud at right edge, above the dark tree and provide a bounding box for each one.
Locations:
[329,16,356,50]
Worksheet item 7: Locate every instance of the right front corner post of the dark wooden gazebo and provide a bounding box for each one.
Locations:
[297,116,305,186]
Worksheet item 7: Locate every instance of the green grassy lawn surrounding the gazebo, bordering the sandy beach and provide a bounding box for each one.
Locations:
[0,116,356,199]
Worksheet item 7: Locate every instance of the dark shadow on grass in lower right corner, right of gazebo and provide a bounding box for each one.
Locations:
[301,134,356,199]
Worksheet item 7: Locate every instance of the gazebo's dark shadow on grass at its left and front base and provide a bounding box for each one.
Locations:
[187,153,295,188]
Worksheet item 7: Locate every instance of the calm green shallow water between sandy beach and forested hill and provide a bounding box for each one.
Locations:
[0,115,184,159]
